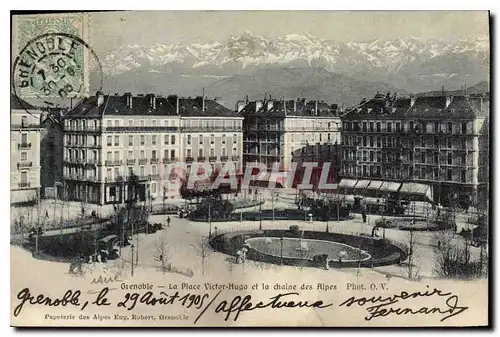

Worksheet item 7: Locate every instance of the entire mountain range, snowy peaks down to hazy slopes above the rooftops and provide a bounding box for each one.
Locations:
[95,32,489,106]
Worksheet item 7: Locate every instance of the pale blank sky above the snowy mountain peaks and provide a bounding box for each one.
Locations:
[90,11,489,55]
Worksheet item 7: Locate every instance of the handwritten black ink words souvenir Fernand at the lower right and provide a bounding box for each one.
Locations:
[339,286,468,322]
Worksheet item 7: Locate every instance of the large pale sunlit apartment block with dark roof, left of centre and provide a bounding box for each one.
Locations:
[64,93,242,204]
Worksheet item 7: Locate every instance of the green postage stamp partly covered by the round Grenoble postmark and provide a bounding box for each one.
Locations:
[12,13,101,105]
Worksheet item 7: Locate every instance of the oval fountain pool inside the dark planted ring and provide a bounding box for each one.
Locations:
[245,237,371,262]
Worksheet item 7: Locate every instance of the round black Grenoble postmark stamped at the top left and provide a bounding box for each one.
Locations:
[12,33,103,110]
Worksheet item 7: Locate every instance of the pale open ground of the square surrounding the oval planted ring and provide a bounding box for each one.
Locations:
[8,188,480,278]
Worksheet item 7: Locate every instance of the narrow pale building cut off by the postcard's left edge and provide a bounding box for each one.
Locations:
[10,94,43,205]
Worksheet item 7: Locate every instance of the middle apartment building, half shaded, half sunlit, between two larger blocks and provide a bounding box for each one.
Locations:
[237,99,341,185]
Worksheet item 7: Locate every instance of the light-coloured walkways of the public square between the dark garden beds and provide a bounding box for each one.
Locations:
[7,190,486,279]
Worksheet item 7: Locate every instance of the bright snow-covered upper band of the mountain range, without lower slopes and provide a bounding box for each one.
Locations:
[101,32,489,76]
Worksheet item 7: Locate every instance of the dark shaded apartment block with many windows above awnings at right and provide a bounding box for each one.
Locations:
[341,94,489,204]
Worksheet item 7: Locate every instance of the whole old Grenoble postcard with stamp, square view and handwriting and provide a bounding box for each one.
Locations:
[10,11,491,327]
